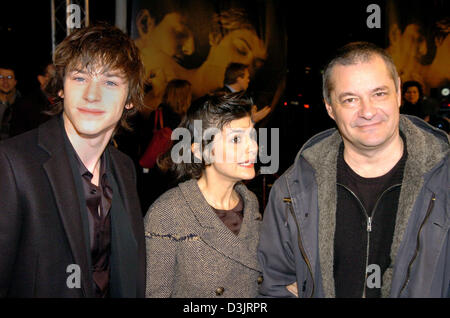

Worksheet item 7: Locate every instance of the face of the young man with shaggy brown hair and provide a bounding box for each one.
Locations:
[61,70,133,138]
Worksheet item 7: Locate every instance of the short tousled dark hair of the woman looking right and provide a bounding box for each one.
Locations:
[157,92,252,182]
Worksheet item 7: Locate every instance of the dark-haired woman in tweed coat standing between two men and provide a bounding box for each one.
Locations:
[144,93,262,298]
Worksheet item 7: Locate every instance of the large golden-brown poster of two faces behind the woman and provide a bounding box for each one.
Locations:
[131,0,287,112]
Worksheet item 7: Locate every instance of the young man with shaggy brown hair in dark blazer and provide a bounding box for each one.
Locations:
[0,24,145,298]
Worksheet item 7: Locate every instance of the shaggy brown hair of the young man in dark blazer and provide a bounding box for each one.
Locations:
[46,23,145,129]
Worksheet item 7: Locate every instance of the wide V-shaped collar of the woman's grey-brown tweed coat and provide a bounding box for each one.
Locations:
[178,179,261,271]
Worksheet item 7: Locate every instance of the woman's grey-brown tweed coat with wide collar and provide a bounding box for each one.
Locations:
[145,180,262,298]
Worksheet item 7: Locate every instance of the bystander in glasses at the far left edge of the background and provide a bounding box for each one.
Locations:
[0,64,21,140]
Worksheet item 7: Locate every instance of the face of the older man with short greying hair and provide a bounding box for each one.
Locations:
[326,56,400,150]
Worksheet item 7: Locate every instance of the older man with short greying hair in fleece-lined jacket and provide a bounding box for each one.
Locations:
[258,42,450,298]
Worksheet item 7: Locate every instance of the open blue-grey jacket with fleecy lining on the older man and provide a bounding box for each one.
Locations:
[258,115,450,297]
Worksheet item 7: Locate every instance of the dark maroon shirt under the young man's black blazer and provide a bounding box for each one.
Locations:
[75,152,113,298]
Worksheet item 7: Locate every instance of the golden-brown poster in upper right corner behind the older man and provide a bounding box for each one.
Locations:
[386,0,450,97]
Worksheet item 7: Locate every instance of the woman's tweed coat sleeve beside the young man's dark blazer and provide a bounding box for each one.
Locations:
[144,198,178,298]
